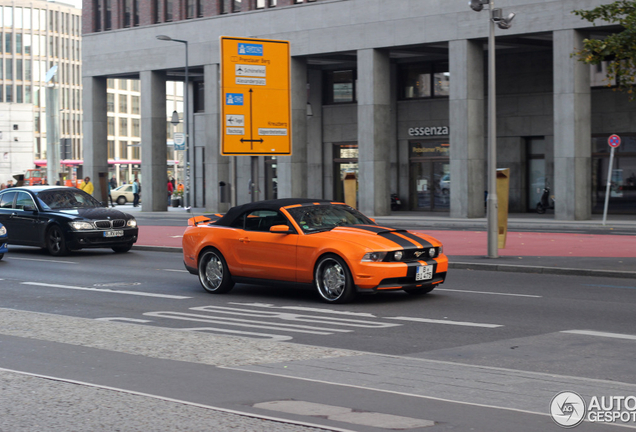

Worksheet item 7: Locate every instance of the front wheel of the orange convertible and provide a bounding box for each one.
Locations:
[314,255,355,303]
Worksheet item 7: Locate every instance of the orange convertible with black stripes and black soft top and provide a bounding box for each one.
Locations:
[183,198,448,303]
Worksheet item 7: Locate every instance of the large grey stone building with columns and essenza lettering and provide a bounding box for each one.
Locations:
[82,0,636,216]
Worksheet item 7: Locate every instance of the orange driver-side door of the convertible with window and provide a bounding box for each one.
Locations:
[234,210,298,282]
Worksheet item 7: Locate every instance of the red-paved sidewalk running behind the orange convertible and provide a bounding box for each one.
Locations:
[128,207,636,279]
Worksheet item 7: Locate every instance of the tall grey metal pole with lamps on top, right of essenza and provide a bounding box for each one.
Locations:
[486,0,499,258]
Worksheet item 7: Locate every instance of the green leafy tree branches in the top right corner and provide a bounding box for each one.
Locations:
[572,0,636,100]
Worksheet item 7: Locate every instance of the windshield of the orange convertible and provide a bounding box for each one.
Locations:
[287,205,375,233]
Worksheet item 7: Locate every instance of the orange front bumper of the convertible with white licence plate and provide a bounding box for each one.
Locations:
[352,254,448,292]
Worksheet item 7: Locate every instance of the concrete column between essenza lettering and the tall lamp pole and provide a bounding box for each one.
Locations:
[449,40,486,218]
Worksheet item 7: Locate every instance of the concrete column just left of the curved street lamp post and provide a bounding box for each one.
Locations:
[139,71,168,212]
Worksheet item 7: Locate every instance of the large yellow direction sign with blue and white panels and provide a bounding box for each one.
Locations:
[221,36,291,156]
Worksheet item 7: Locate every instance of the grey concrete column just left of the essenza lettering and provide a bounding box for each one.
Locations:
[358,49,392,216]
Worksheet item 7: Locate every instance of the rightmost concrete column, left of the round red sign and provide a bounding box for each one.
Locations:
[553,30,592,220]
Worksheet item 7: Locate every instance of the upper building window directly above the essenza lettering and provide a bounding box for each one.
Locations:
[399,63,450,99]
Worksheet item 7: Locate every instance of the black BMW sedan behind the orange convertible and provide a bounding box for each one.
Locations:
[0,186,139,256]
